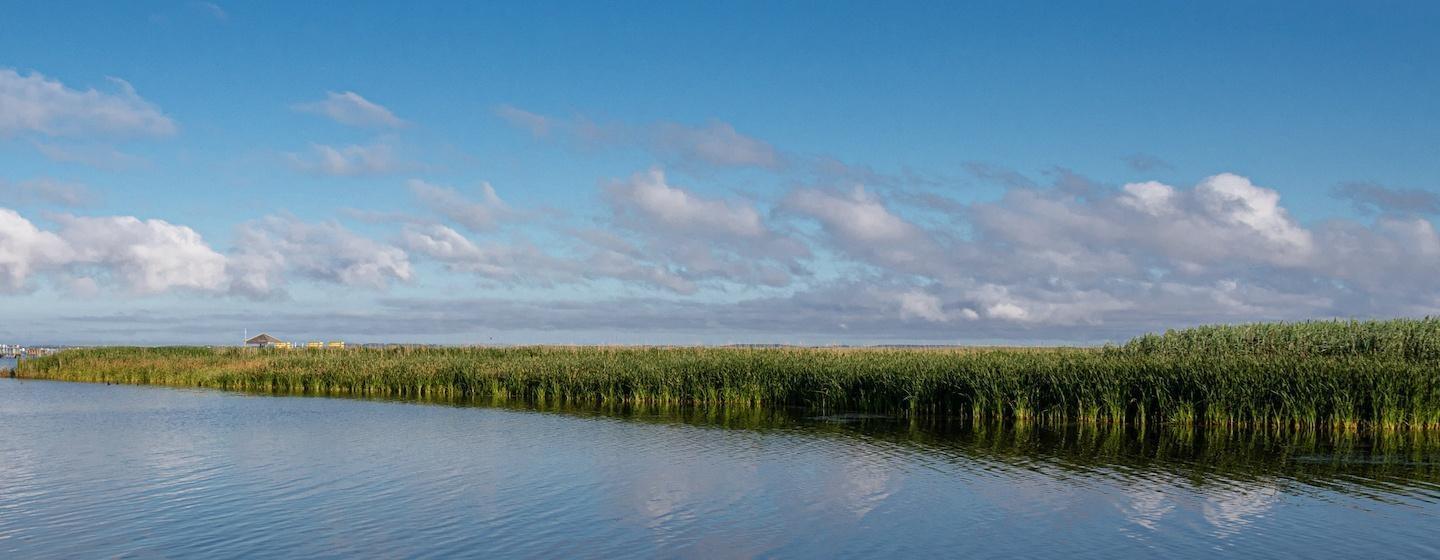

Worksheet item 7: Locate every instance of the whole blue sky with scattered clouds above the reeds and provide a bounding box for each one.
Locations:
[0,1,1440,344]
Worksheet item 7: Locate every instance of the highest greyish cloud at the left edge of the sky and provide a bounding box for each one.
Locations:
[0,69,177,137]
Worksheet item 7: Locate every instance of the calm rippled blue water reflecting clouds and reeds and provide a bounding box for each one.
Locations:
[0,379,1440,559]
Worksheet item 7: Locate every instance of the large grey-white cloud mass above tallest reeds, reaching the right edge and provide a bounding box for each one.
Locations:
[783,167,1440,331]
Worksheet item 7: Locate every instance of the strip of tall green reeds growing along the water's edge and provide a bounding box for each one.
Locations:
[13,318,1440,430]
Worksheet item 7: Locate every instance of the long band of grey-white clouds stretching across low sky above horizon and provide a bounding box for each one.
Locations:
[0,167,1440,341]
